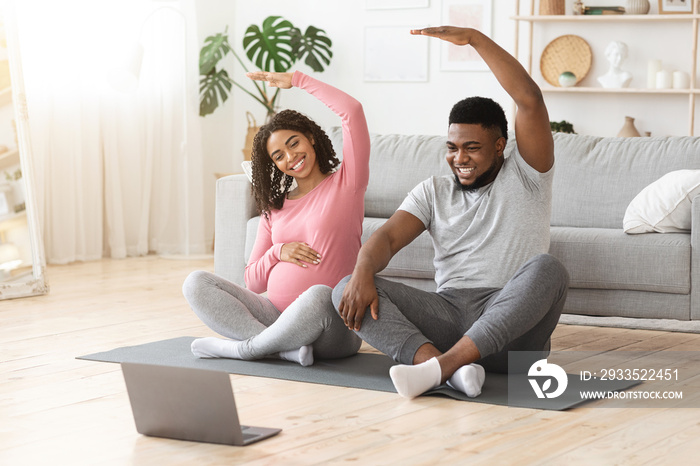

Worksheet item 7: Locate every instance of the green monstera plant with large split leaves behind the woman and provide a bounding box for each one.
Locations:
[199,16,333,116]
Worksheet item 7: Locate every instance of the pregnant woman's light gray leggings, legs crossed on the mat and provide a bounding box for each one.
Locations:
[182,271,362,359]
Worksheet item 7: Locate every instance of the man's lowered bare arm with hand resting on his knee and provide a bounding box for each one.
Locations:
[338,210,425,330]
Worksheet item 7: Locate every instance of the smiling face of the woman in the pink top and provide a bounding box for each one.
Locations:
[267,129,319,178]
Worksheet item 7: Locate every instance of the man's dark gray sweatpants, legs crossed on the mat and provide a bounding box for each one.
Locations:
[333,254,569,372]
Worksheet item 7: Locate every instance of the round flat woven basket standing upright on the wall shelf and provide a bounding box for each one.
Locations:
[540,34,593,87]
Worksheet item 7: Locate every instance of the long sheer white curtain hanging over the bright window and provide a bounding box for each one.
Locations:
[16,0,207,263]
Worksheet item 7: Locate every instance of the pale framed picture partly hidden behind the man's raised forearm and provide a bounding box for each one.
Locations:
[440,0,490,71]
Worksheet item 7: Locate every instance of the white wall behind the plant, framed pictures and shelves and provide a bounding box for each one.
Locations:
[197,0,691,242]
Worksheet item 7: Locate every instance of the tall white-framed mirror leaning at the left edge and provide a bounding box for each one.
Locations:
[0,2,48,299]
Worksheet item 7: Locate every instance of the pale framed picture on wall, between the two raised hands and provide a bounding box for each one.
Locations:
[364,26,428,82]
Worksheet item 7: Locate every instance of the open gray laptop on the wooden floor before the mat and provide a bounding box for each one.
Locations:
[121,363,282,446]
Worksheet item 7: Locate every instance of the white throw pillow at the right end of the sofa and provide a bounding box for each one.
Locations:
[622,170,700,234]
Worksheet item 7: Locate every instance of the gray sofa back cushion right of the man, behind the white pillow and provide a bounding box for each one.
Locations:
[551,133,700,229]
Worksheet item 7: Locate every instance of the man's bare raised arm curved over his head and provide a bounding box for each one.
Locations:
[411,26,554,173]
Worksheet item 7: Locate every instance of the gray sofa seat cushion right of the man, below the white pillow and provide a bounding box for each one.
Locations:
[549,227,691,294]
